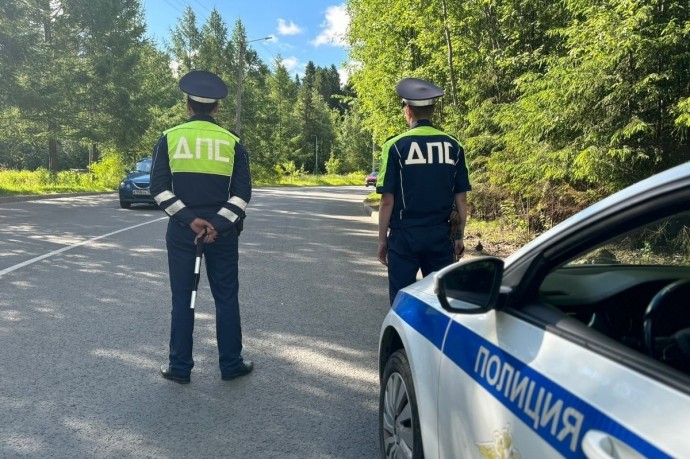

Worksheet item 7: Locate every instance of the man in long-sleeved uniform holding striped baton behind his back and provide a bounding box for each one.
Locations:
[151,70,253,384]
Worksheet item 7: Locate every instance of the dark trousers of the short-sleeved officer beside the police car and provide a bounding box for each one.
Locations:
[388,224,455,304]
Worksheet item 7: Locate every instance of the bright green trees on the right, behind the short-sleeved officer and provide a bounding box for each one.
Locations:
[348,0,690,229]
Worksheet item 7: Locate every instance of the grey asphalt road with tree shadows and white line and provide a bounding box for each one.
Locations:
[0,187,388,458]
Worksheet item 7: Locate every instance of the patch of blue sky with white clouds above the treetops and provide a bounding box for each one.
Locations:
[142,0,349,80]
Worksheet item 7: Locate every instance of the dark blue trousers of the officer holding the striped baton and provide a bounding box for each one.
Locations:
[165,219,242,376]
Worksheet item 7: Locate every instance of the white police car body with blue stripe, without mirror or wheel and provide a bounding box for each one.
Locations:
[380,165,690,459]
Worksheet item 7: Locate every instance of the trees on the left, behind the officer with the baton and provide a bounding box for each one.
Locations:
[0,0,372,182]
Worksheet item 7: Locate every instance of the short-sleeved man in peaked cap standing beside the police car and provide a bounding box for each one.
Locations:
[376,78,471,304]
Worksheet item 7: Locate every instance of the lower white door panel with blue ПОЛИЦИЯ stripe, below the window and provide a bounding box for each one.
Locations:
[438,305,690,458]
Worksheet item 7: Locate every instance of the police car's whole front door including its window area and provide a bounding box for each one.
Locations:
[438,207,690,458]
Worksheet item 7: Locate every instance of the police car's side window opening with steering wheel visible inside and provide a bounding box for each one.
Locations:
[539,212,690,375]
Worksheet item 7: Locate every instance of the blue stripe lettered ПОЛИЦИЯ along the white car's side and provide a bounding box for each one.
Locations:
[393,292,671,459]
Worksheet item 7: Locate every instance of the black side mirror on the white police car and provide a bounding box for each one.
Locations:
[434,257,503,314]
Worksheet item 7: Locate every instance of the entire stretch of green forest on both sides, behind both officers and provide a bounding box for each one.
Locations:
[0,0,690,230]
